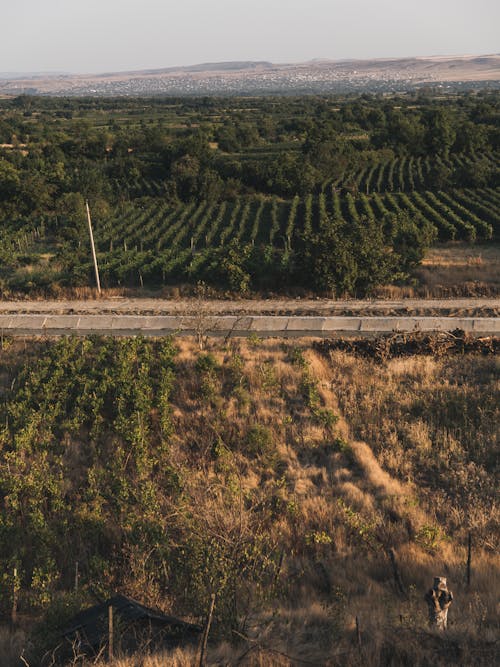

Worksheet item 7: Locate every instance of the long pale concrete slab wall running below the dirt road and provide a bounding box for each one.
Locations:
[0,315,500,337]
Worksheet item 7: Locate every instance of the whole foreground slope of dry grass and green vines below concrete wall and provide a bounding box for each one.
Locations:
[0,340,498,665]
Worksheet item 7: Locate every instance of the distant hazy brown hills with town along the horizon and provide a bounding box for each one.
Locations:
[0,54,500,95]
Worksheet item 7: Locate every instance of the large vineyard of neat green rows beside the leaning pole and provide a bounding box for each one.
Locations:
[71,186,500,285]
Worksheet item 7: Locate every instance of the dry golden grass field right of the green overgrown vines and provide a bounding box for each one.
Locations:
[0,339,499,667]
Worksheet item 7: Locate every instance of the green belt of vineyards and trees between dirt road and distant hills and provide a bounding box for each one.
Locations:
[0,94,500,298]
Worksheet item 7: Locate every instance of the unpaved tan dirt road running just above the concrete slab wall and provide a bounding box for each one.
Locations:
[0,297,500,317]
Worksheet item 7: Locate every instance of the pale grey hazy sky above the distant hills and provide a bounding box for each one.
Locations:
[0,0,500,72]
